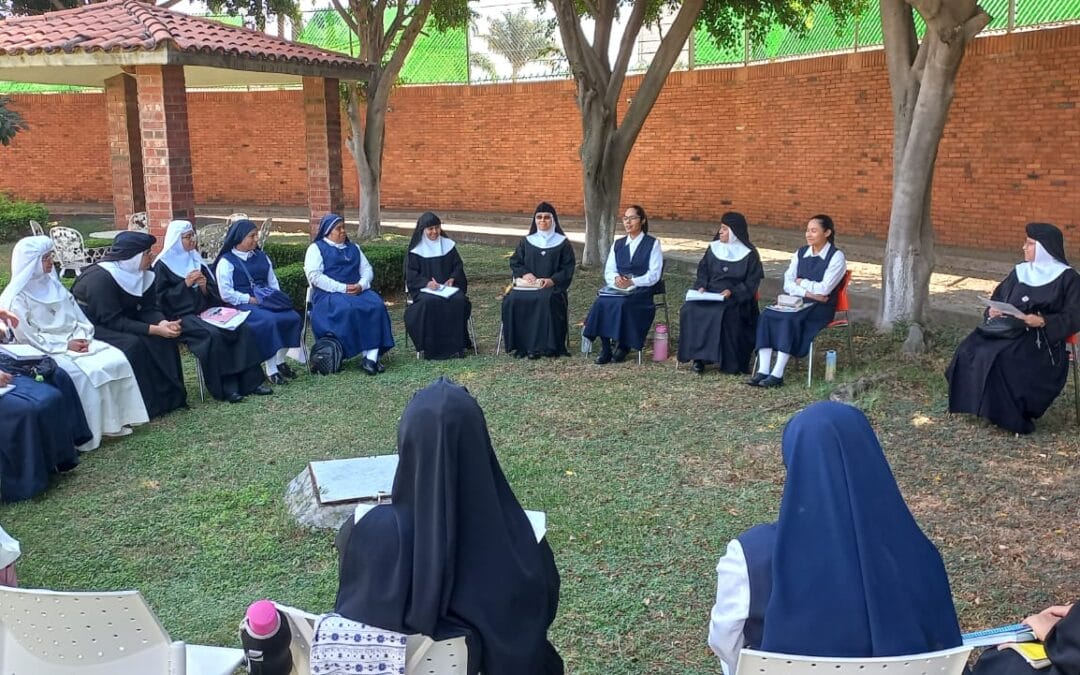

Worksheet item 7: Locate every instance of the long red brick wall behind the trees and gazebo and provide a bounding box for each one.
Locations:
[0,26,1080,249]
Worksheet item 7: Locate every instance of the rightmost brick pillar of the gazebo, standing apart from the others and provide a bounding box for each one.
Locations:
[303,78,345,233]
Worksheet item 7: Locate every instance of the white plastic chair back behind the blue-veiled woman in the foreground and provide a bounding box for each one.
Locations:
[735,647,971,675]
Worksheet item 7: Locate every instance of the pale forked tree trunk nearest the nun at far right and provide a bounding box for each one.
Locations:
[878,0,989,351]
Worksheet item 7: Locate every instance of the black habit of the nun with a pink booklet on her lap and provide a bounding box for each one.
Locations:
[153,261,266,401]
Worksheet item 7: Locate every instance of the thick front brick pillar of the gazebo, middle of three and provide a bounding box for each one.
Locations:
[135,66,195,249]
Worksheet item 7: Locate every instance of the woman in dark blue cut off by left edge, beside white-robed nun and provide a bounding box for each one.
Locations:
[0,310,86,501]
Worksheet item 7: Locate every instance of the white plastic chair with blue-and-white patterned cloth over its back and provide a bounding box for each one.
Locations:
[274,603,466,675]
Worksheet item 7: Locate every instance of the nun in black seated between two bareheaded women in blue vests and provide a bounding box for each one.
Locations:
[678,211,765,374]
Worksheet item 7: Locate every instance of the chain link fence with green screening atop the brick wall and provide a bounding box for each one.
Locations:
[0,0,1080,94]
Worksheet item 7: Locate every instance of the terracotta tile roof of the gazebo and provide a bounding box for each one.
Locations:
[0,0,363,68]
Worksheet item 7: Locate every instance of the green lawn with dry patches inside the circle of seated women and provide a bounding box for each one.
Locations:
[0,239,1080,675]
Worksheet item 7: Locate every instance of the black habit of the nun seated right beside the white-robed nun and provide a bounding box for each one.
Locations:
[71,265,188,419]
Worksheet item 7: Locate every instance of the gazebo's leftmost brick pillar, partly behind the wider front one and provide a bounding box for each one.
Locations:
[105,75,146,229]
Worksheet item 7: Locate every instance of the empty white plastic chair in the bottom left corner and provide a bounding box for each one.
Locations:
[0,586,244,675]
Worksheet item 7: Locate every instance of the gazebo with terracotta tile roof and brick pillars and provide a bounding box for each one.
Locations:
[0,0,369,239]
